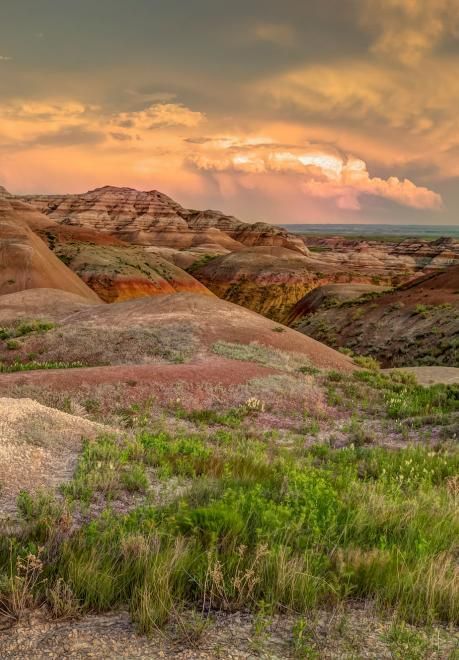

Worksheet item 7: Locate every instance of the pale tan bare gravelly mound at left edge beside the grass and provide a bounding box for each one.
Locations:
[0,398,105,516]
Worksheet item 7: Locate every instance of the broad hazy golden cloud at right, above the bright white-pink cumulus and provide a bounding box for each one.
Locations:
[254,55,459,180]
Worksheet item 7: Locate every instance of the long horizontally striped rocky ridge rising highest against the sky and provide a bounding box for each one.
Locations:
[23,186,307,254]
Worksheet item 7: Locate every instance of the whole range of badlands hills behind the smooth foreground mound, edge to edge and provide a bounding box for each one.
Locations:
[0,186,459,366]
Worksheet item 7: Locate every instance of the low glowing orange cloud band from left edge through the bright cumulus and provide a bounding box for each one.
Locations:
[0,95,442,215]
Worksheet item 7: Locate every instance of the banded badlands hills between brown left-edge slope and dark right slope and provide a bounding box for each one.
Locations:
[9,186,459,322]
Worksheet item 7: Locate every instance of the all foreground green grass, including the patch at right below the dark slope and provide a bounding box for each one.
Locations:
[0,371,459,636]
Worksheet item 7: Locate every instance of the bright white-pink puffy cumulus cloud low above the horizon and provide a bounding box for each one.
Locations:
[188,138,442,210]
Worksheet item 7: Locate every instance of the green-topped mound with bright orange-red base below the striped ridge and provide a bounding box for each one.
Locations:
[50,243,212,303]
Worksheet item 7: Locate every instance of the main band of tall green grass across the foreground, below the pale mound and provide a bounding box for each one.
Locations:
[0,431,459,632]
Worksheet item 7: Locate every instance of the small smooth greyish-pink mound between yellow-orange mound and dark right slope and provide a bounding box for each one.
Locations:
[288,284,386,324]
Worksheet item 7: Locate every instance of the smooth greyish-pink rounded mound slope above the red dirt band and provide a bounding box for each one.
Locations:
[0,293,353,370]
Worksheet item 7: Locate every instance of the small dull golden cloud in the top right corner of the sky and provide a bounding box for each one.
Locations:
[360,0,459,66]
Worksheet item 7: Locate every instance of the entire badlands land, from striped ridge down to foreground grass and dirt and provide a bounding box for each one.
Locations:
[0,182,459,660]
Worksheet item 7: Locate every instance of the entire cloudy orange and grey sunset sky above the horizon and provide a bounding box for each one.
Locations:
[0,0,459,225]
